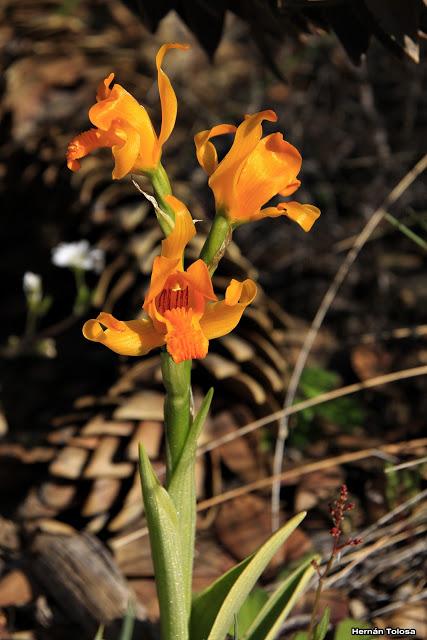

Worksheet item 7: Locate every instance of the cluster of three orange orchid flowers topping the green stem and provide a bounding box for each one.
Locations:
[67,43,320,363]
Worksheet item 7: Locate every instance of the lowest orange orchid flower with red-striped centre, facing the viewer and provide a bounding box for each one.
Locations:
[83,195,256,363]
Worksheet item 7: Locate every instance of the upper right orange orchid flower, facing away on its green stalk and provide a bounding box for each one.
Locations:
[194,111,320,231]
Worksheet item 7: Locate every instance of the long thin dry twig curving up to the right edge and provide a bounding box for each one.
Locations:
[271,154,427,531]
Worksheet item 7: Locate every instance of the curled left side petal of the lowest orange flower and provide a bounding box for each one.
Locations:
[83,312,165,356]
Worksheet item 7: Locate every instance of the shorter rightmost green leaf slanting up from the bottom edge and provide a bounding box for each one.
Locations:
[244,556,320,640]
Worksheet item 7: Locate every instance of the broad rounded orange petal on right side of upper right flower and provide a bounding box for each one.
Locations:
[229,133,302,220]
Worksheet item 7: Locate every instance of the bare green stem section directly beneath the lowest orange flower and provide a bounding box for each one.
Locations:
[161,351,191,482]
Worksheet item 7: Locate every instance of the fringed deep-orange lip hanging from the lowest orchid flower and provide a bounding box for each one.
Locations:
[165,309,209,364]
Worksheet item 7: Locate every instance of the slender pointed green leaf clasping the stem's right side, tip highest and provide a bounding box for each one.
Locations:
[168,389,214,612]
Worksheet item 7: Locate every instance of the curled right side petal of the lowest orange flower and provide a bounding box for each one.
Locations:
[200,279,256,340]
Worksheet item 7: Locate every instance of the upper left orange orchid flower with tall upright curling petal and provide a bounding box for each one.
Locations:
[67,43,189,179]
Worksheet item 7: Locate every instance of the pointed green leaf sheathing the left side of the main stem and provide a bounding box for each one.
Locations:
[139,444,188,640]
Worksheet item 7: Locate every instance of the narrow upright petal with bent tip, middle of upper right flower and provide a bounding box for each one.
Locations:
[209,110,277,208]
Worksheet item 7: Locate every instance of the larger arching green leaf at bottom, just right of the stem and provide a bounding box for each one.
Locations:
[190,512,306,640]
